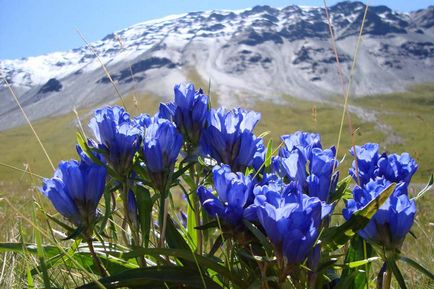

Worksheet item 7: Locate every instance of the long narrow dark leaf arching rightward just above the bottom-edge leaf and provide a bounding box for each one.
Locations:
[124,248,245,286]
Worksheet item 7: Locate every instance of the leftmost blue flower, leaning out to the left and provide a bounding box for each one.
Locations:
[41,156,106,227]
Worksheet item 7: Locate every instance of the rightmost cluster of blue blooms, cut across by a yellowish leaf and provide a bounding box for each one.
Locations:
[343,143,417,249]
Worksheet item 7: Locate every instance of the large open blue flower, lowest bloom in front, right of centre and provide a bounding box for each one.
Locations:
[252,182,332,264]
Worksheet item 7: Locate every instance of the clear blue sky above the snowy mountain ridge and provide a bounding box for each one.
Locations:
[0,0,434,59]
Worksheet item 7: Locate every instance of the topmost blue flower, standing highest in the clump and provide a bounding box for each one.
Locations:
[158,83,209,146]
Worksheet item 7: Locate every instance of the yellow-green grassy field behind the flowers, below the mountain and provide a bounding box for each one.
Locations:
[0,80,434,288]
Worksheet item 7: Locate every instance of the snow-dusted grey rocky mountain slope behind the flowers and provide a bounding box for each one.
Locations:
[0,1,434,129]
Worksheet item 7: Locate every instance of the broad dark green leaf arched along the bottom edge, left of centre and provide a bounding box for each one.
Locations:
[78,266,221,289]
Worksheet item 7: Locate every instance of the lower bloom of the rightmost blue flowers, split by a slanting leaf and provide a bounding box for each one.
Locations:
[343,178,416,249]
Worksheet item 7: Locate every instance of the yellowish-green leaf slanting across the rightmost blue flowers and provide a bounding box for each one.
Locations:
[320,183,396,251]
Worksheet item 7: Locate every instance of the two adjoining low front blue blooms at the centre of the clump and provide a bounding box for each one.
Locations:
[198,137,332,265]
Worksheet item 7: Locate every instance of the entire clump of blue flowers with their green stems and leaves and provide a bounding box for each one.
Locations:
[37,84,424,288]
